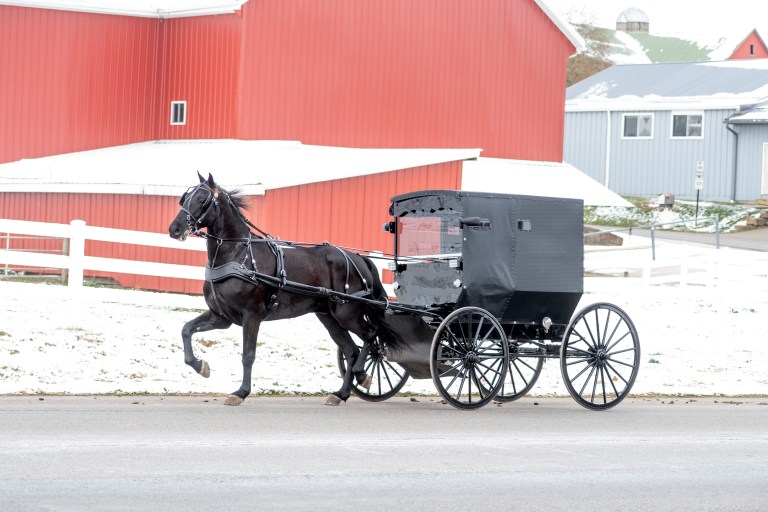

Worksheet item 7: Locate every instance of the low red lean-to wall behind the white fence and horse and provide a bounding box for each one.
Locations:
[0,162,461,293]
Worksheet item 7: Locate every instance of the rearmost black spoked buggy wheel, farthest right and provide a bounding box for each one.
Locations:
[560,303,640,410]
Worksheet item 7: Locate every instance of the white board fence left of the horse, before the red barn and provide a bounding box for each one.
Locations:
[0,219,205,288]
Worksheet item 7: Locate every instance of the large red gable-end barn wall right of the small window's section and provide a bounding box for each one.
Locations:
[238,0,573,161]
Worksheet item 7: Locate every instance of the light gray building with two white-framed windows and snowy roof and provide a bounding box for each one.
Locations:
[563,59,768,201]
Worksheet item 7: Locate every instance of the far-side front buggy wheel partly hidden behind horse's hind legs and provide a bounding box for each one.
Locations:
[337,337,410,402]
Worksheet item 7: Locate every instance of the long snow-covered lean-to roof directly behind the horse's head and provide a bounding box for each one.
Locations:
[0,139,481,195]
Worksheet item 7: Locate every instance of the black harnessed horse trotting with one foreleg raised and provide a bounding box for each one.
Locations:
[168,173,386,405]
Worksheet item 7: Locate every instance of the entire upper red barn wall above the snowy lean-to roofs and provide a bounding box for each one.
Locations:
[0,0,573,163]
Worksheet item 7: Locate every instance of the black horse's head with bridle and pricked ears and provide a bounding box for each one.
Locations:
[168,173,220,241]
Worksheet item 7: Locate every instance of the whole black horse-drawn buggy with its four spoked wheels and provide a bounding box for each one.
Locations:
[338,190,640,410]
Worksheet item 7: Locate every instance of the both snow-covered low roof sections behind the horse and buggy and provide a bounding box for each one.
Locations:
[0,139,629,206]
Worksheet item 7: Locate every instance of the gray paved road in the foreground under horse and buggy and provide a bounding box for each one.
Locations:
[0,396,768,512]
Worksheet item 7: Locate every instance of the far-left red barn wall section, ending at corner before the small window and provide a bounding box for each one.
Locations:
[0,6,158,163]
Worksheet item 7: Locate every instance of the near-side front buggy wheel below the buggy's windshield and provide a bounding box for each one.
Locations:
[429,307,509,409]
